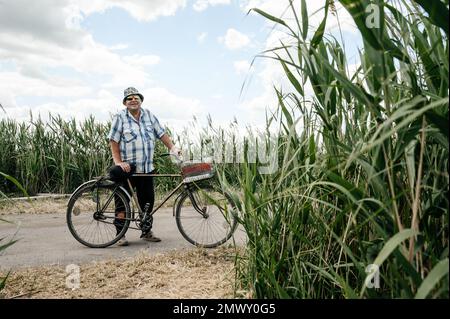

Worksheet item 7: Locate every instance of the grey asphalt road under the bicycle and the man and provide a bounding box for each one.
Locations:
[0,208,245,270]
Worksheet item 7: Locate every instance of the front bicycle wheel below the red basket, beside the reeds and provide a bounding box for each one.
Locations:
[176,188,237,248]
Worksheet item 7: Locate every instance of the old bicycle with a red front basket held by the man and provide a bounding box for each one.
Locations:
[66,154,237,248]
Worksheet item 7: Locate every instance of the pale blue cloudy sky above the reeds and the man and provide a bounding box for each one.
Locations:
[0,0,359,131]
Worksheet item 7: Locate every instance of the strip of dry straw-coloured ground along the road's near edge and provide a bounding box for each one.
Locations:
[0,248,243,299]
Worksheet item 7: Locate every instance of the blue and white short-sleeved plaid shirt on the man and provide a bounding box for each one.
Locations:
[108,108,165,173]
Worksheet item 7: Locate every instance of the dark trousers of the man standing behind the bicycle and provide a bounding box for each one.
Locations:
[110,166,155,233]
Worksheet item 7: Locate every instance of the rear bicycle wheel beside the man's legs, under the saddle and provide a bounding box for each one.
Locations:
[66,181,131,248]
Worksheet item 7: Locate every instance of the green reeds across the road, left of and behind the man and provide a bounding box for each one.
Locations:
[0,115,179,195]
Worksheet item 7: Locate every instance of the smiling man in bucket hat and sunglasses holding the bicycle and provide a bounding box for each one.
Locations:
[108,87,181,246]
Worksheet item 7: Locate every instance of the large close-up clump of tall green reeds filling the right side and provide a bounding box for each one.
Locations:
[221,0,449,298]
